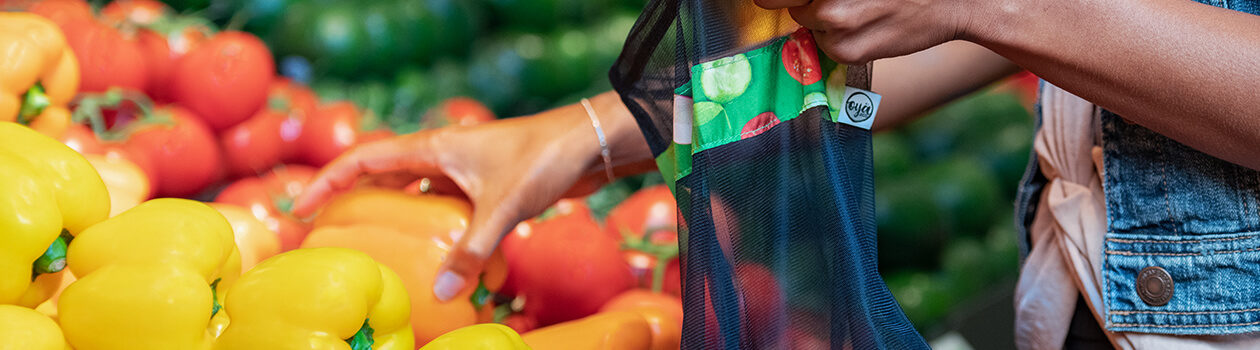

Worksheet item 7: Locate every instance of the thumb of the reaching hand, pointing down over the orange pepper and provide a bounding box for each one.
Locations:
[433,203,519,302]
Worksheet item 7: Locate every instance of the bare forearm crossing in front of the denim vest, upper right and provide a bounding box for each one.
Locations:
[968,0,1260,169]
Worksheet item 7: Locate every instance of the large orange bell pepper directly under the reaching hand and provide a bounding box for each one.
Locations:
[301,189,507,344]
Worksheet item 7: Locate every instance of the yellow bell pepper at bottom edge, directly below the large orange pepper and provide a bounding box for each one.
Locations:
[215,248,416,350]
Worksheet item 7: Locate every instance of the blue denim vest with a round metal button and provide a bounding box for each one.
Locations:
[1016,0,1260,335]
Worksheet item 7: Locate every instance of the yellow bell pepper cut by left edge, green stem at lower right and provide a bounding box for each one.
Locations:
[0,122,110,307]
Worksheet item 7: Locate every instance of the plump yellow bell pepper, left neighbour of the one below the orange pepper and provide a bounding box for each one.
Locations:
[58,198,241,350]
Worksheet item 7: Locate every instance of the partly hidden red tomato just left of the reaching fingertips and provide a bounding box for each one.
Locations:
[214,165,316,251]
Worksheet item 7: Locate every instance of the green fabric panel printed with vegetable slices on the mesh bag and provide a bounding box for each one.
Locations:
[690,29,844,155]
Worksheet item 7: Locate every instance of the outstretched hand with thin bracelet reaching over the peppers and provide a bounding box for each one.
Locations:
[294,93,650,301]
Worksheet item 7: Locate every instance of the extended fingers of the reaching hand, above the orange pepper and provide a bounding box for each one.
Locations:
[294,135,437,218]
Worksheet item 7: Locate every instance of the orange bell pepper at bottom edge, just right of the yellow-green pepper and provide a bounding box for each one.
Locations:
[522,311,653,350]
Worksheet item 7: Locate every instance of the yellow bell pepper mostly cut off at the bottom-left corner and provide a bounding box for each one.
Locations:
[0,305,71,350]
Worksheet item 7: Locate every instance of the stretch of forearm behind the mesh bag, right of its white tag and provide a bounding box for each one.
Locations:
[872,42,1019,131]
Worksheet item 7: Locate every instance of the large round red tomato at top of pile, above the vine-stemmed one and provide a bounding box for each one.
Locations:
[171,31,276,131]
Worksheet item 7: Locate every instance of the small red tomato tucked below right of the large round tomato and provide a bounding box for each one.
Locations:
[219,110,287,176]
